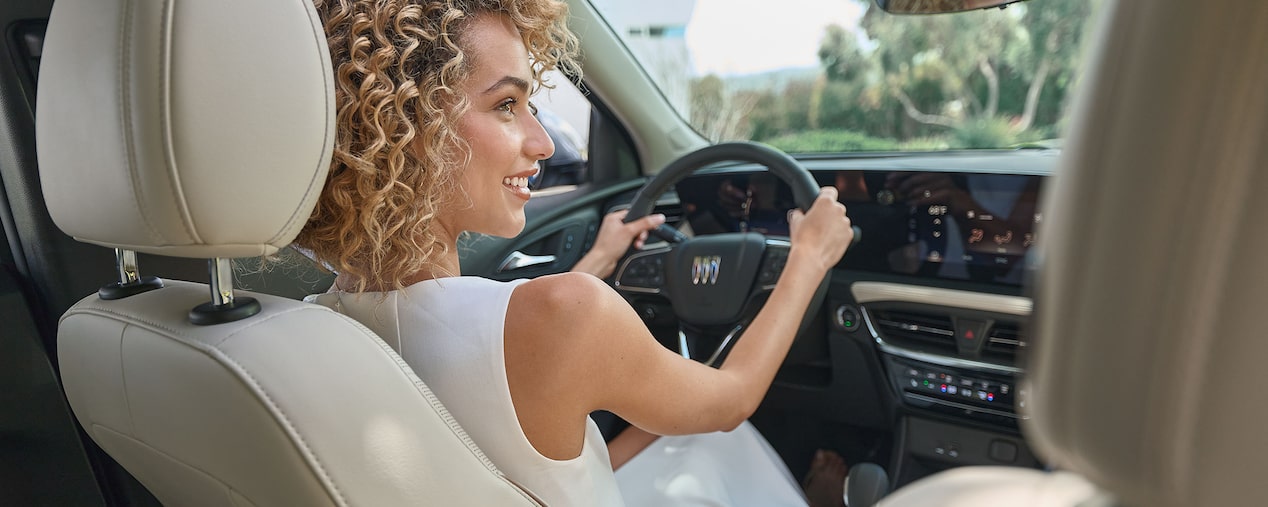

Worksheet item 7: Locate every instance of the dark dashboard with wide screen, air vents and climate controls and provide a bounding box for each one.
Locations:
[628,151,1055,485]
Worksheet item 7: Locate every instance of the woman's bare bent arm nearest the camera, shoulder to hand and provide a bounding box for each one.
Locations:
[506,188,852,459]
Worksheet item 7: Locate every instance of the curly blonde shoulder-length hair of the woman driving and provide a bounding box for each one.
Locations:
[295,0,579,292]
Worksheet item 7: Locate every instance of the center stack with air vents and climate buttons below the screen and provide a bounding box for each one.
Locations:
[836,281,1038,485]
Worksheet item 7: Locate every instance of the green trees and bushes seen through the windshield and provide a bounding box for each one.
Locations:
[691,0,1097,152]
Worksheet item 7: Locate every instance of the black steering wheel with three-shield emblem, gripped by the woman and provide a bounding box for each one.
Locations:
[614,142,828,365]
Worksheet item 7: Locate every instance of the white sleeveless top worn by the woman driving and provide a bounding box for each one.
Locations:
[306,276,623,506]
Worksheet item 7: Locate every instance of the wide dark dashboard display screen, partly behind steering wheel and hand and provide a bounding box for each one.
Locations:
[678,171,1042,285]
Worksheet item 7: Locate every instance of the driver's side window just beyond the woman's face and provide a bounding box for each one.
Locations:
[529,72,591,194]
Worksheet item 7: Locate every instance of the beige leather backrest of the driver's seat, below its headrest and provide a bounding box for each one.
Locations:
[58,281,533,506]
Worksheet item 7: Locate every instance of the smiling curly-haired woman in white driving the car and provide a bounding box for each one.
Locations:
[297,0,851,504]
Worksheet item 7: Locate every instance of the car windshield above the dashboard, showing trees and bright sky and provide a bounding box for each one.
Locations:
[592,0,1094,153]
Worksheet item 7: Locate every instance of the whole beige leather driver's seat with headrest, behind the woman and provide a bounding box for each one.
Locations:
[37,0,536,506]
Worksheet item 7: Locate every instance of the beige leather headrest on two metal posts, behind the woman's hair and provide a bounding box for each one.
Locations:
[36,0,335,257]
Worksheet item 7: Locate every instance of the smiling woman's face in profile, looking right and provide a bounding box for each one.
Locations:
[439,14,554,237]
